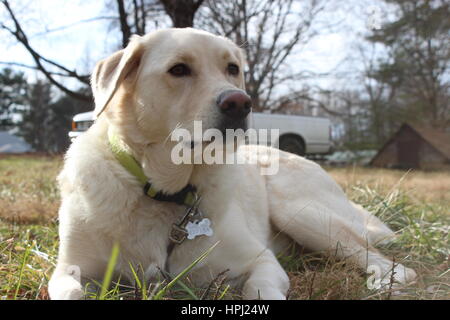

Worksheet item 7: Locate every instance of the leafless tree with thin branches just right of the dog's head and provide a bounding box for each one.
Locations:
[200,0,325,110]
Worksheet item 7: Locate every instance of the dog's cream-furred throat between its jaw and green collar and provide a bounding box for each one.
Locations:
[109,127,194,194]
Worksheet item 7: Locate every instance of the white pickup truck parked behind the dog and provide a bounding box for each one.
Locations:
[69,112,331,156]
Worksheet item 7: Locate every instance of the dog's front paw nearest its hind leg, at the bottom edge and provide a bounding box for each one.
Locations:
[242,250,289,300]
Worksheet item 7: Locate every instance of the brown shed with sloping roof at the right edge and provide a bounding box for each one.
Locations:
[370,123,450,169]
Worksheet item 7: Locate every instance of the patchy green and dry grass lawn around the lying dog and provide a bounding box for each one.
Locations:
[0,156,450,299]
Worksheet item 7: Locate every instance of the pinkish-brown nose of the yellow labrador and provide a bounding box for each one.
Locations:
[217,90,252,120]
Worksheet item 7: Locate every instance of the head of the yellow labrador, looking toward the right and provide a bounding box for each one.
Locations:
[92,29,251,143]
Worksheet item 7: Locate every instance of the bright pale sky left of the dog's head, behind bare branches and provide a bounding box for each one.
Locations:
[0,0,117,80]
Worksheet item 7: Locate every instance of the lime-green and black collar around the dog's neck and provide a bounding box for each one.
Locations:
[108,132,198,207]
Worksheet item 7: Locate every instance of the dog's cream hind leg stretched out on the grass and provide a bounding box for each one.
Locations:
[255,147,415,283]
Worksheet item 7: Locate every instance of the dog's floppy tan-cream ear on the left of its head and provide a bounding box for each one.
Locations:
[91,36,144,118]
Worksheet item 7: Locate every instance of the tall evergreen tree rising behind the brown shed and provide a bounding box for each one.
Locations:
[368,0,450,127]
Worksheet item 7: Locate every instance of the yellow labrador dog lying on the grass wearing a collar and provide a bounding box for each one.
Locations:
[49,29,415,299]
